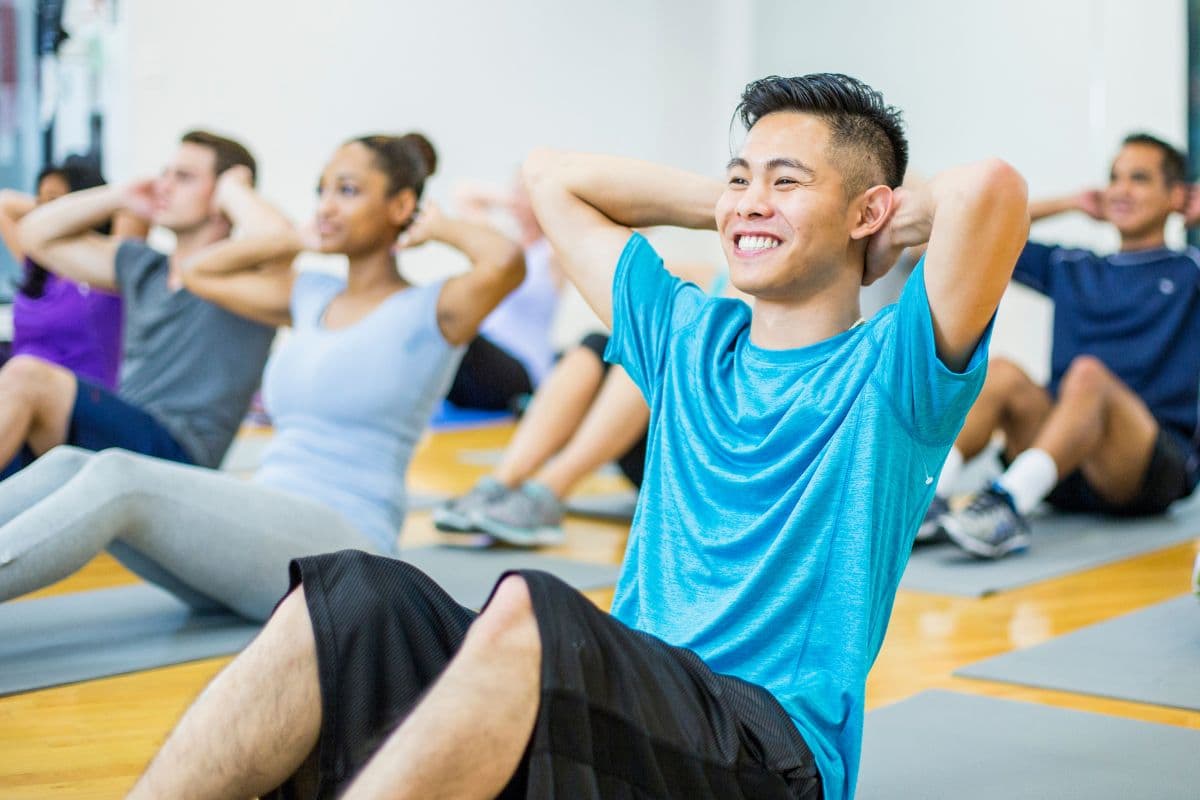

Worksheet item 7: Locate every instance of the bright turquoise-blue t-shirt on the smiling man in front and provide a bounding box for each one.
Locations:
[606,234,988,800]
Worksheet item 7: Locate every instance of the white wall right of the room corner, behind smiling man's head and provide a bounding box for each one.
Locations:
[751,0,1187,377]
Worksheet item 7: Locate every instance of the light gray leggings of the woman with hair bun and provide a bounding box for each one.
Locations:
[0,446,379,620]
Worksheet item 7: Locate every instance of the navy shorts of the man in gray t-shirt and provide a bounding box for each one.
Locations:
[0,378,196,480]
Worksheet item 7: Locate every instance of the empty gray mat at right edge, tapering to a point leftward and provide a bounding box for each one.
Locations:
[955,595,1200,714]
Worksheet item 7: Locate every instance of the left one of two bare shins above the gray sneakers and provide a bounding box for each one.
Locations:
[493,347,604,488]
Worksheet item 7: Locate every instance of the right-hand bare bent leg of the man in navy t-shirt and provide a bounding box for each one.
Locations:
[1033,356,1158,503]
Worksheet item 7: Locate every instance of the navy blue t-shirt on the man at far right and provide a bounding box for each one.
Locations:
[1013,242,1200,450]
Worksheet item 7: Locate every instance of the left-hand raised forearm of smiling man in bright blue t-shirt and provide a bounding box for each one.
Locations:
[524,150,722,230]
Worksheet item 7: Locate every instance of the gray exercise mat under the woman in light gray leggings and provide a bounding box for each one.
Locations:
[0,547,618,696]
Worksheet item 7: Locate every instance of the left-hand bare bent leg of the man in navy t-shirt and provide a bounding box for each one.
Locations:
[954,359,1050,461]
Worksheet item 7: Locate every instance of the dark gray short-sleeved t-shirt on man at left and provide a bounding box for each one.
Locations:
[116,241,275,467]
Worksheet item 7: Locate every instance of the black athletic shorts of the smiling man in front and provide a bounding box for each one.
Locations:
[263,551,821,800]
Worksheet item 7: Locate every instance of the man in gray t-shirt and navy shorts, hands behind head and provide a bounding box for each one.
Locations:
[9,131,275,476]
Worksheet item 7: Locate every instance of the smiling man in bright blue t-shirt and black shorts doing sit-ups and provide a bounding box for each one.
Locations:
[131,74,1028,800]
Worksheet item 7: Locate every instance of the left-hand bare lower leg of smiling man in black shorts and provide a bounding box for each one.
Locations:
[130,587,320,800]
